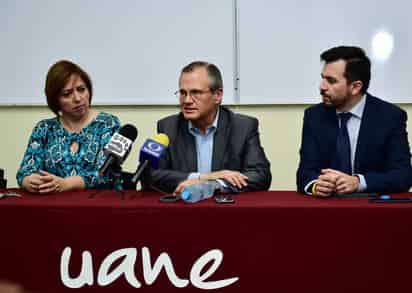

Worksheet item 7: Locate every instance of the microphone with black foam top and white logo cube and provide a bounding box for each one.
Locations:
[99,124,137,176]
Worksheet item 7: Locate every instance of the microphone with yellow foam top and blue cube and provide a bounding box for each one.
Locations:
[131,133,169,185]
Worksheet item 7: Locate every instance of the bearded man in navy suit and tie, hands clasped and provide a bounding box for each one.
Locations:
[297,46,412,197]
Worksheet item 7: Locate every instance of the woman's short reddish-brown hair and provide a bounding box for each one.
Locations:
[44,60,93,115]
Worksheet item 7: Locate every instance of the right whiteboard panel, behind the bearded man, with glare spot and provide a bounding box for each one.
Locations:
[237,0,412,104]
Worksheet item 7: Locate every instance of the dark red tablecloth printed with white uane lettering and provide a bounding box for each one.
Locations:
[0,191,412,293]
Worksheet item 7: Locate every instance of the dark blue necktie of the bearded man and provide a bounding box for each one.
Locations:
[335,113,352,175]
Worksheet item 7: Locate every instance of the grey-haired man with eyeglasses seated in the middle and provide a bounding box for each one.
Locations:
[148,61,272,195]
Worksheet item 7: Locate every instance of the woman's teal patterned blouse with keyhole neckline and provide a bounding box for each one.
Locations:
[16,112,120,189]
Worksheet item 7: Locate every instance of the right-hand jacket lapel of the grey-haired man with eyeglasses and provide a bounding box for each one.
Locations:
[212,107,231,171]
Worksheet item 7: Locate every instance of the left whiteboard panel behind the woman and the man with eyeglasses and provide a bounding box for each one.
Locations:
[0,0,234,105]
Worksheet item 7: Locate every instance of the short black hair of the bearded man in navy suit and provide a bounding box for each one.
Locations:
[320,46,371,94]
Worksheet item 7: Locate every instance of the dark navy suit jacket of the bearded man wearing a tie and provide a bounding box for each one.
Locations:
[297,94,412,193]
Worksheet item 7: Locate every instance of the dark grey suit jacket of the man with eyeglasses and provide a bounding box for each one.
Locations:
[144,106,272,192]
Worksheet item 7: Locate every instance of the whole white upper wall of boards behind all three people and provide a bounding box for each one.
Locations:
[0,0,412,105]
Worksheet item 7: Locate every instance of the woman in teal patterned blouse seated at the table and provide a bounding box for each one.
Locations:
[17,60,120,193]
